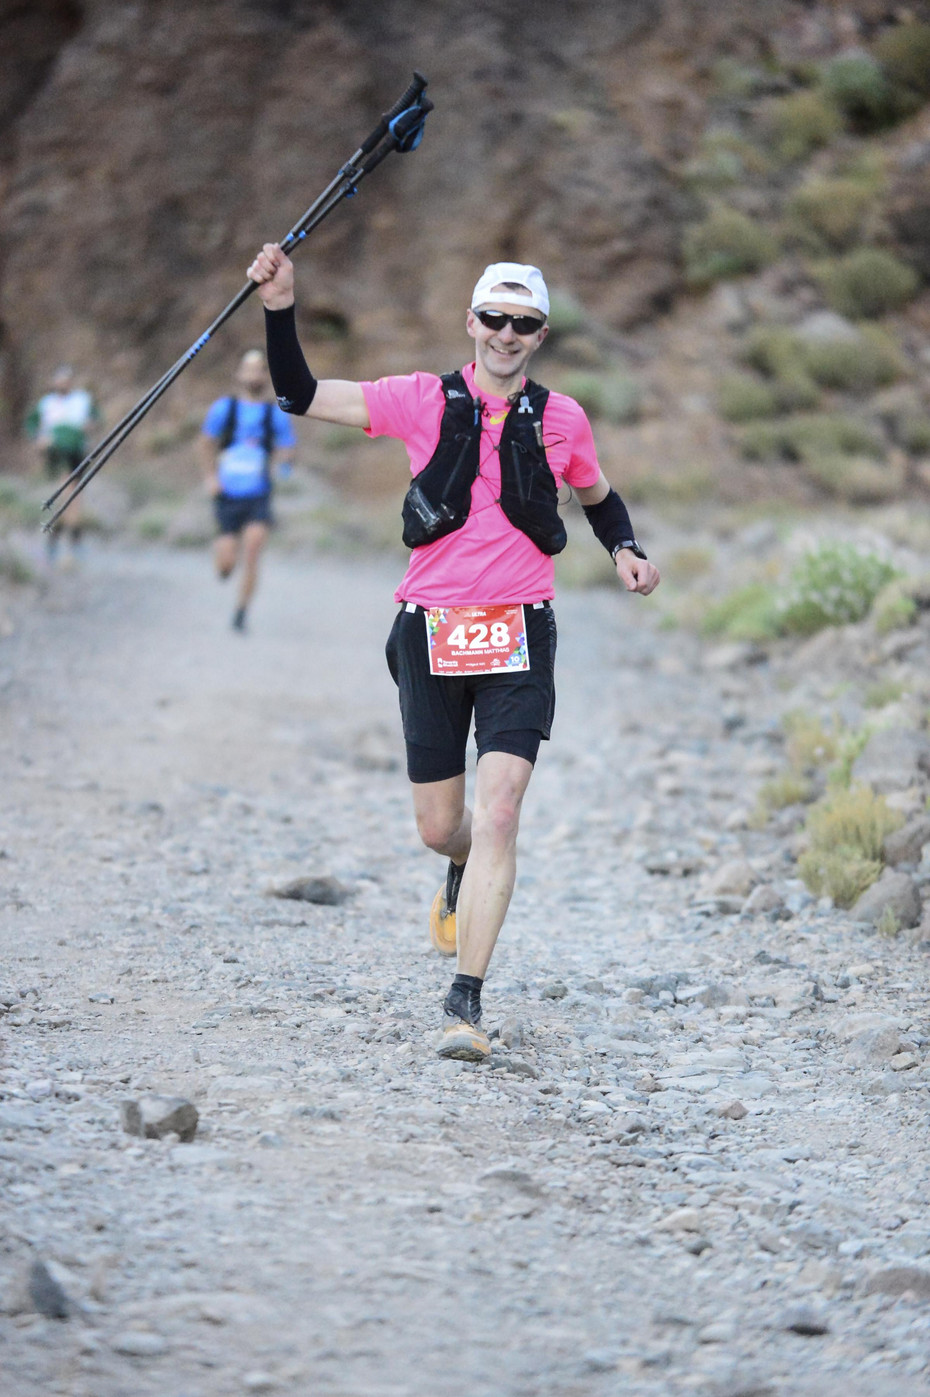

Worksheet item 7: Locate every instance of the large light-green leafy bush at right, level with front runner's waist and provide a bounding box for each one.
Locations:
[778,543,898,636]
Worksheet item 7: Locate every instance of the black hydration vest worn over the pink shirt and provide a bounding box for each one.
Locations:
[402,372,567,553]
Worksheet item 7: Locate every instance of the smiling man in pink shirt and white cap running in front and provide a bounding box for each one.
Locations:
[242,243,659,1062]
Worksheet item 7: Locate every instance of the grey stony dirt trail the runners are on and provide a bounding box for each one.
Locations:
[0,546,930,1397]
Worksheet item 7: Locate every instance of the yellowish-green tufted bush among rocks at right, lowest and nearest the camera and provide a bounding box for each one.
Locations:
[797,785,903,907]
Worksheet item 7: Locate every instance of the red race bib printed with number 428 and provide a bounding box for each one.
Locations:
[426,604,529,679]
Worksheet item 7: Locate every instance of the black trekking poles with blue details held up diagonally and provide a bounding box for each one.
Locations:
[42,73,433,532]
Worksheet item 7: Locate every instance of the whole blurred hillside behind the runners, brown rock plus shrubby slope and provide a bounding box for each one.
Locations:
[0,0,930,500]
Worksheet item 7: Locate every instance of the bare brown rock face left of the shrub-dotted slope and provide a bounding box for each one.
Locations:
[0,0,803,435]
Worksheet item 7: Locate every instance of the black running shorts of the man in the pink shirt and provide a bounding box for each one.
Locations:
[385,602,556,782]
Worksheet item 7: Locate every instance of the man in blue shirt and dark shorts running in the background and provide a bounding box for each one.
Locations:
[200,349,297,630]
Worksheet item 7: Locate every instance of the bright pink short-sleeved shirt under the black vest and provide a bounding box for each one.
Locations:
[362,363,600,606]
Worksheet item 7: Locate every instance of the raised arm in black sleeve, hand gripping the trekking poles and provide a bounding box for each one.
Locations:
[246,243,370,427]
